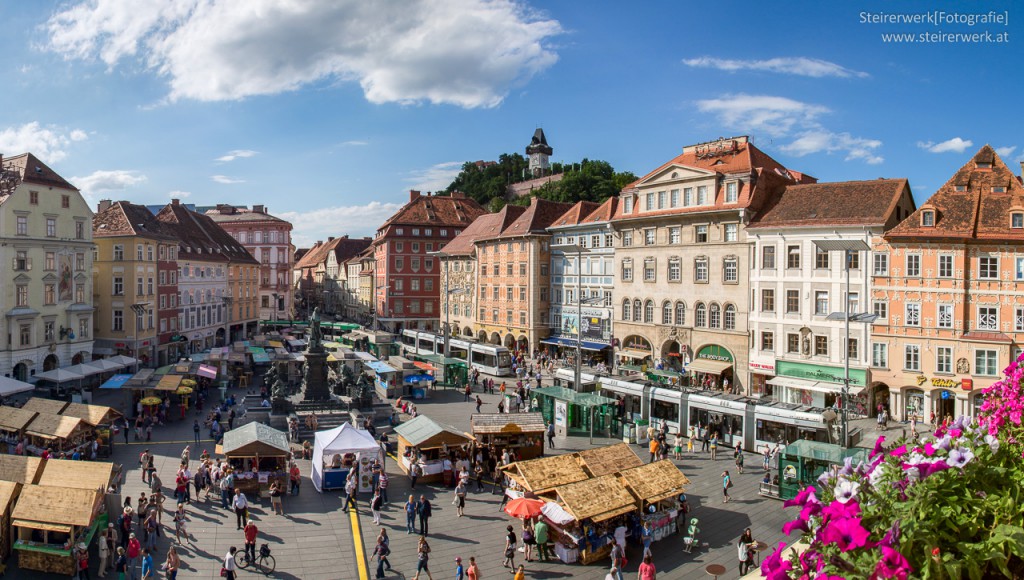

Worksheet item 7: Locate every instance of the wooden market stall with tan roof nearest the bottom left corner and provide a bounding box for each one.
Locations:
[11,485,108,577]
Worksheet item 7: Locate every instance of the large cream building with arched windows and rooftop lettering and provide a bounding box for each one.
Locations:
[612,136,813,392]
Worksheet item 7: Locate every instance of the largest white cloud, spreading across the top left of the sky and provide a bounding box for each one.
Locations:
[44,0,562,108]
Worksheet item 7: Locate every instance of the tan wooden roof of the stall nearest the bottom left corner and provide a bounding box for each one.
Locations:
[11,486,103,532]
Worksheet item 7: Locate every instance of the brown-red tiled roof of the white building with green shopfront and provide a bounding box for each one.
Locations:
[746,178,909,229]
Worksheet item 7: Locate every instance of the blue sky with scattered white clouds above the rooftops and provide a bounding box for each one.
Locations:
[0,0,1024,247]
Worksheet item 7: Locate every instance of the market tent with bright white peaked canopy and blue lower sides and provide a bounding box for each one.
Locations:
[310,423,381,492]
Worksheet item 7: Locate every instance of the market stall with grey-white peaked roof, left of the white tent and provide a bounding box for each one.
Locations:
[216,422,291,497]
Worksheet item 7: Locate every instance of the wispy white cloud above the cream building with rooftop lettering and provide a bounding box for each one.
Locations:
[696,94,885,165]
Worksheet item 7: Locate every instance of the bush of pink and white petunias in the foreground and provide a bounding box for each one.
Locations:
[761,355,1024,580]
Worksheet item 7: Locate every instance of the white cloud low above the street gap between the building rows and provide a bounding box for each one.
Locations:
[284,201,402,248]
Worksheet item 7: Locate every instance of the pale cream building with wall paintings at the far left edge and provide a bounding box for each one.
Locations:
[0,153,93,380]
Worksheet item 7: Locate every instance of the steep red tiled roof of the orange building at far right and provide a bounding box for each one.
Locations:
[886,144,1024,241]
